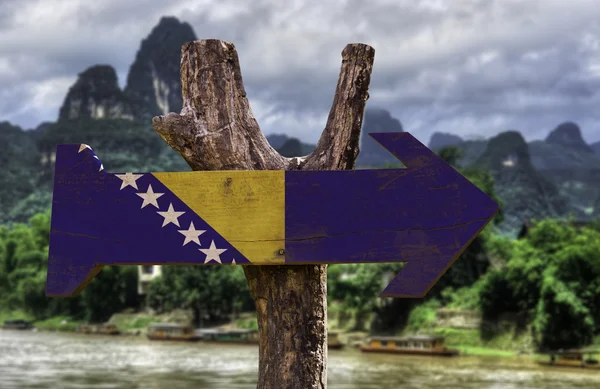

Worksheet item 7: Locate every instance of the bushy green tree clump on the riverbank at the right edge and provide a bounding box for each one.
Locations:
[480,219,600,349]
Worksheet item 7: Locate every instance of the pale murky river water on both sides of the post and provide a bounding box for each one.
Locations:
[0,330,600,389]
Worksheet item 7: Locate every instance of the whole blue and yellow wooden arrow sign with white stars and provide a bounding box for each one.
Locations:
[46,132,498,297]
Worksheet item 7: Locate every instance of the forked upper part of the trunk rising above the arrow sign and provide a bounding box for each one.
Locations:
[152,39,375,170]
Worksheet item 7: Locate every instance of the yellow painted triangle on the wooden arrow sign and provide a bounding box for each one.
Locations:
[152,170,285,265]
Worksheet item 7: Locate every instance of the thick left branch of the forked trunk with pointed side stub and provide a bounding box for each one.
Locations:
[152,40,287,170]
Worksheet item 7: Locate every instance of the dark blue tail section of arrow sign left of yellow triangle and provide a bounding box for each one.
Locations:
[46,145,250,296]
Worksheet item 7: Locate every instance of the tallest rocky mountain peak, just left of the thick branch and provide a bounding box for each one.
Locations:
[125,16,197,120]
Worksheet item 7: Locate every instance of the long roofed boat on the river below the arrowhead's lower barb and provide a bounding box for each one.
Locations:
[360,336,458,357]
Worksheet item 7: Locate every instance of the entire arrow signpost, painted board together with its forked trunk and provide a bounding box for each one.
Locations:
[46,40,498,389]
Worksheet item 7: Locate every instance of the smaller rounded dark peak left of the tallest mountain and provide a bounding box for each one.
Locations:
[58,65,133,120]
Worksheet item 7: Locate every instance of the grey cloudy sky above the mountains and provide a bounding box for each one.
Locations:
[0,0,600,142]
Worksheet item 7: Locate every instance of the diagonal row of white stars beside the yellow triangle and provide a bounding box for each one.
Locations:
[115,173,235,265]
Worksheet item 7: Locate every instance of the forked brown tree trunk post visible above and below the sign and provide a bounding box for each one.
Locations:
[152,40,375,389]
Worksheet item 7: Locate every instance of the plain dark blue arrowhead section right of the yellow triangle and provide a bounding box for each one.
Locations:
[285,132,498,298]
